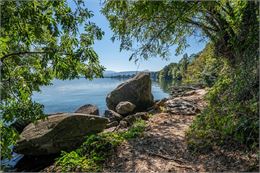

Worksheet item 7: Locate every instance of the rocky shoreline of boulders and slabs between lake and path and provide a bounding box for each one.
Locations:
[2,73,205,171]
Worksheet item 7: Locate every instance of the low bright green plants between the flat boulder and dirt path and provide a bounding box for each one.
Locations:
[55,120,146,172]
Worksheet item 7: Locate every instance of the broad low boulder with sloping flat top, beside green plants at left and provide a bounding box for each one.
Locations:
[14,113,108,155]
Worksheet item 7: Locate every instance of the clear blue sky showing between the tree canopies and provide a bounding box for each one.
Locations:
[71,0,205,72]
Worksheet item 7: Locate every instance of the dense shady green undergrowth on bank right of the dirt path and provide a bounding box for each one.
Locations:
[187,64,259,151]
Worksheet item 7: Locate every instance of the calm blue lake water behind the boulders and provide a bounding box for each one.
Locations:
[33,78,169,114]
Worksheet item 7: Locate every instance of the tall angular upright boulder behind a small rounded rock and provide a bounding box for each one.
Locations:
[106,72,153,111]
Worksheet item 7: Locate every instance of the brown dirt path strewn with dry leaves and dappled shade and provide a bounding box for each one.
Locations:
[104,90,256,172]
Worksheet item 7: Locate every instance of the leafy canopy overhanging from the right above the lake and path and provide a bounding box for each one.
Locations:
[103,0,259,64]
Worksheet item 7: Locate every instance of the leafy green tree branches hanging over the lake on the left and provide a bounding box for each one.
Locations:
[0,0,104,157]
